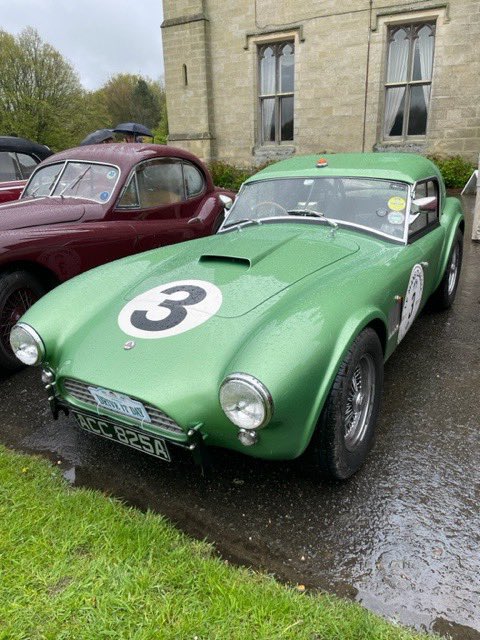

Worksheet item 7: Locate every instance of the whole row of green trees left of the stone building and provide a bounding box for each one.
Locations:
[0,27,167,151]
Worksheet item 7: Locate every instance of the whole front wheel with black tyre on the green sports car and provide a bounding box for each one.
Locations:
[309,328,383,480]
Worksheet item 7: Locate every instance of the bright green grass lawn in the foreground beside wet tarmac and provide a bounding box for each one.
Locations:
[0,447,430,640]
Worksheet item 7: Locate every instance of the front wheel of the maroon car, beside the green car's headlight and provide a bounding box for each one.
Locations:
[0,271,45,373]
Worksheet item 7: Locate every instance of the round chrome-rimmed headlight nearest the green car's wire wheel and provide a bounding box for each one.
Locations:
[220,373,273,429]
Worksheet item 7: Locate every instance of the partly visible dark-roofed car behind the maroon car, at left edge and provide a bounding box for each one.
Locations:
[0,136,52,204]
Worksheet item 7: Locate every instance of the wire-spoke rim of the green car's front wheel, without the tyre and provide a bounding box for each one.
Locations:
[344,353,376,451]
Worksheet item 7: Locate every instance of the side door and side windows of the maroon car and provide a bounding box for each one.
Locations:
[114,157,211,251]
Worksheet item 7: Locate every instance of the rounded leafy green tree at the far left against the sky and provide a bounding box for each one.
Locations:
[0,27,92,149]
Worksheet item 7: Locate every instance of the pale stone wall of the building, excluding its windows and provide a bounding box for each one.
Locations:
[162,0,480,164]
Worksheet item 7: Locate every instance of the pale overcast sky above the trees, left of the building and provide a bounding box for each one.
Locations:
[0,0,163,89]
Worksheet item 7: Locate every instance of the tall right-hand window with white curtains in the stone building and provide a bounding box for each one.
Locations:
[384,23,435,139]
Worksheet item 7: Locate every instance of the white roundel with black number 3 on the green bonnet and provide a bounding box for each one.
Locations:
[118,280,222,339]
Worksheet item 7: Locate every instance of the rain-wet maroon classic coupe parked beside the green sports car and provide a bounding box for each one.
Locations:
[0,143,235,371]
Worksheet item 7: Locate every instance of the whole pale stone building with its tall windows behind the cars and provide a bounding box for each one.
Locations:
[162,0,480,165]
